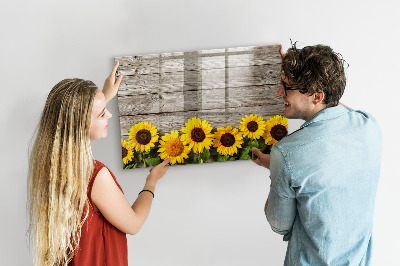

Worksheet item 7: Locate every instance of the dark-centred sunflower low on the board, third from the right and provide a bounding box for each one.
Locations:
[214,126,243,155]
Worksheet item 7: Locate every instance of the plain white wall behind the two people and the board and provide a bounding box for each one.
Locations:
[0,0,400,265]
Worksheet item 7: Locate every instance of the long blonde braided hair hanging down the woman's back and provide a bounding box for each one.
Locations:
[28,79,97,265]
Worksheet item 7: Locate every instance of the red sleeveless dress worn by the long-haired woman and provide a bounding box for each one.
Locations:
[68,160,128,266]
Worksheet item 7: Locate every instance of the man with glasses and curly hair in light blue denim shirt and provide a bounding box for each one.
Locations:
[252,44,381,266]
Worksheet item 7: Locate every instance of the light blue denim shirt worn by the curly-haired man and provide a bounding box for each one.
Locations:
[266,106,381,266]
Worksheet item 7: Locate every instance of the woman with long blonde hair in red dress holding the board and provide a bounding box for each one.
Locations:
[28,62,169,265]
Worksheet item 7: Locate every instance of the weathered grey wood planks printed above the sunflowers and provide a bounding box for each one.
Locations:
[115,45,284,140]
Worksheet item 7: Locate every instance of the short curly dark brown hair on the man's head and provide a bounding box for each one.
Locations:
[282,42,347,107]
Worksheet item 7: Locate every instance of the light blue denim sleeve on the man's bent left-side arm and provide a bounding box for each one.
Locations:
[266,147,297,241]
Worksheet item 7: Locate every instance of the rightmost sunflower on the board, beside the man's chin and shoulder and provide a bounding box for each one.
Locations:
[263,115,288,146]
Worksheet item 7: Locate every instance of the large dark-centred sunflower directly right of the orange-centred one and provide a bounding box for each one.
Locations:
[182,117,214,153]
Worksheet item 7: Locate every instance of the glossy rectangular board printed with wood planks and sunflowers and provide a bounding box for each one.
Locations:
[115,45,288,169]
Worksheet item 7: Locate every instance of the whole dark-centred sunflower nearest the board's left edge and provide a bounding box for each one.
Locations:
[129,122,158,152]
